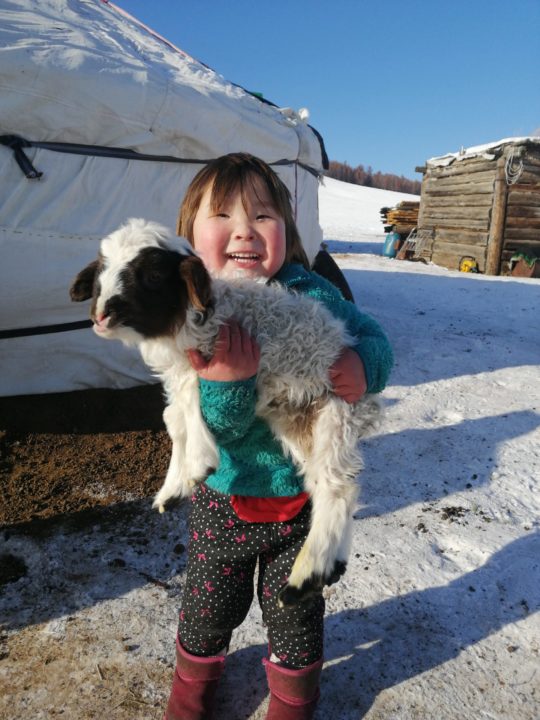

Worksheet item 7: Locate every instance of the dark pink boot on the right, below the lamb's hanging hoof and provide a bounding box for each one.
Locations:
[263,659,323,720]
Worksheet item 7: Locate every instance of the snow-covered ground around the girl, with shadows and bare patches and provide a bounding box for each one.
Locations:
[0,179,540,720]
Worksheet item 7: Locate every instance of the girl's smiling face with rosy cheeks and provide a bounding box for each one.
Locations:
[193,178,286,278]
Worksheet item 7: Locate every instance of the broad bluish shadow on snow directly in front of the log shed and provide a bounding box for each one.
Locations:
[344,260,540,386]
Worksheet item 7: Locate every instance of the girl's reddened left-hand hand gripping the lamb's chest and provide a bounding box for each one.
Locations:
[187,321,261,382]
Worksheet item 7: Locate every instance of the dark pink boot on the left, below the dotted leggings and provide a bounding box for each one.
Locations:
[163,638,225,720]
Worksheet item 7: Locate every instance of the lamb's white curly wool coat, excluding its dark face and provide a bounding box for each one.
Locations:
[76,221,379,603]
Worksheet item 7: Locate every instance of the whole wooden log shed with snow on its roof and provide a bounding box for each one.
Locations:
[416,137,540,275]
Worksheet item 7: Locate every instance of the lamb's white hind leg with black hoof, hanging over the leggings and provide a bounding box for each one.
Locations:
[278,398,362,606]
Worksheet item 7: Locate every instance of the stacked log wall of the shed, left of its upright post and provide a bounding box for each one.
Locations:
[418,158,497,272]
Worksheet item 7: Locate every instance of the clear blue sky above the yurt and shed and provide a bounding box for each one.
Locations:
[116,0,540,179]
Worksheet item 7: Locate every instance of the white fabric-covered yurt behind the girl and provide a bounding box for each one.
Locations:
[0,0,327,396]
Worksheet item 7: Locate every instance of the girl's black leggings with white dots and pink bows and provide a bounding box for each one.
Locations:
[178,484,324,669]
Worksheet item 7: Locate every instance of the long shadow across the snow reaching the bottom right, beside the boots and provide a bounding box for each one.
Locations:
[320,533,540,720]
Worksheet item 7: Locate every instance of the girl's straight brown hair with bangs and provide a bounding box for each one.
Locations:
[176,153,309,270]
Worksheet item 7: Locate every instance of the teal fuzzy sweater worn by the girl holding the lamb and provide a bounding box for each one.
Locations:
[199,264,393,497]
